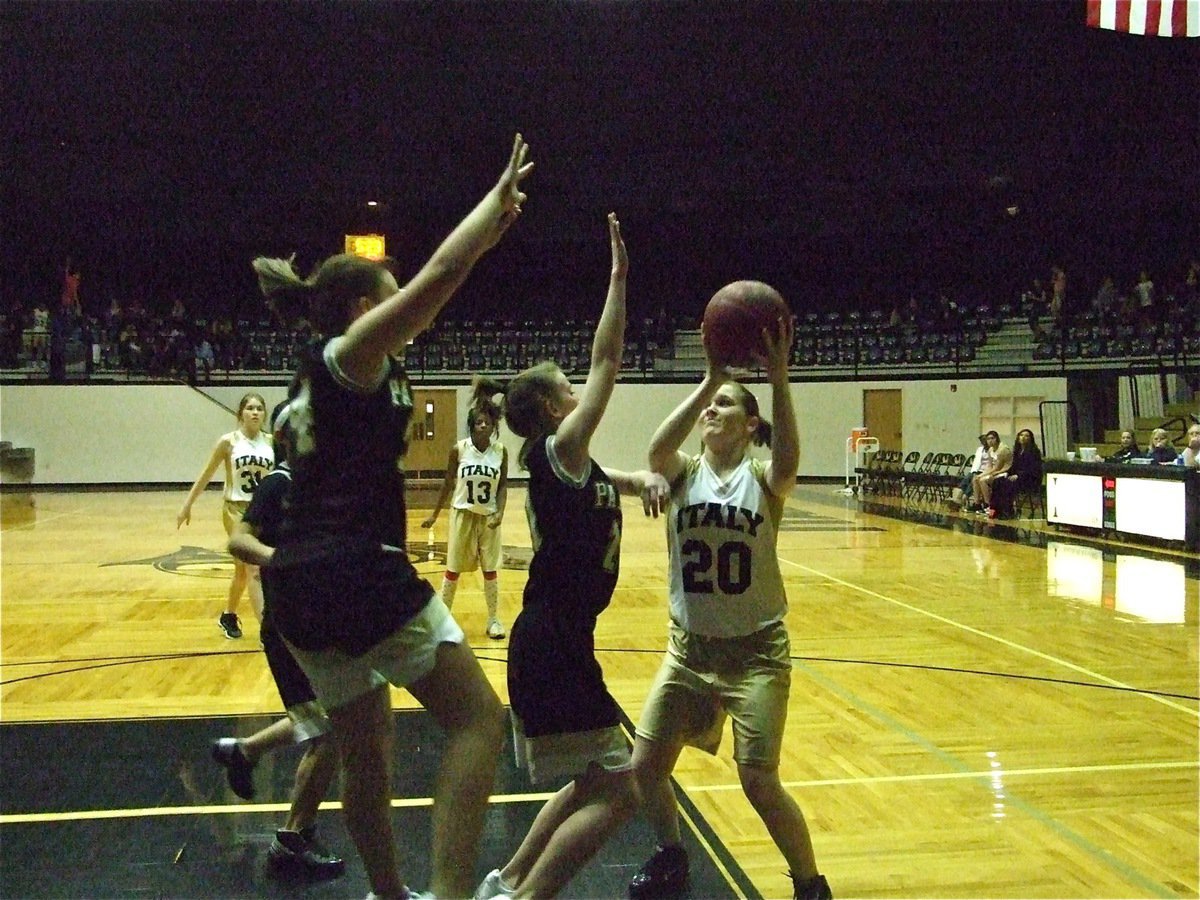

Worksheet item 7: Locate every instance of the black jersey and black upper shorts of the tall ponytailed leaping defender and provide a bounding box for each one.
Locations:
[264,338,433,654]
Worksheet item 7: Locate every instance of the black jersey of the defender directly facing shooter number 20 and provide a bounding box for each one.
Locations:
[524,436,622,618]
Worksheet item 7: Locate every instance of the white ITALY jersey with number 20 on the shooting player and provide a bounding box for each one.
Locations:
[667,456,787,637]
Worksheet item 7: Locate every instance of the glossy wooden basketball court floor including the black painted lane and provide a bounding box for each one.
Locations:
[0,485,1200,898]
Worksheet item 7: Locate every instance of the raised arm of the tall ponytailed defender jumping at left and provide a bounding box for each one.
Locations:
[336,134,533,384]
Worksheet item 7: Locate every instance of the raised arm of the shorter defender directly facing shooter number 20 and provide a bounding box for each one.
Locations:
[554,212,629,475]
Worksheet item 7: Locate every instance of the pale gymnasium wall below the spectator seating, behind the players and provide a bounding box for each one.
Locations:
[0,378,1067,485]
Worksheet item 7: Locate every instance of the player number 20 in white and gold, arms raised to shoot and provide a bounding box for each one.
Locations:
[629,301,832,900]
